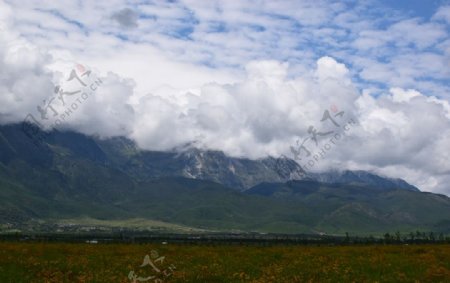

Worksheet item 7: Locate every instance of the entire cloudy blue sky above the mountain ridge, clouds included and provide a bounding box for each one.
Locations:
[0,0,450,195]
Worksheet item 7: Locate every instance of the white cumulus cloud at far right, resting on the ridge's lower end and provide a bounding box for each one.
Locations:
[342,88,450,193]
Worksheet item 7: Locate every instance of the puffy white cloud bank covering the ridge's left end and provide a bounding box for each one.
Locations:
[0,10,134,137]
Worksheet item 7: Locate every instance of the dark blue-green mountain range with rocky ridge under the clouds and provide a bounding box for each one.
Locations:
[0,124,450,234]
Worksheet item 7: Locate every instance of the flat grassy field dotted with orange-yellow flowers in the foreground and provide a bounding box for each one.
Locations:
[0,242,450,283]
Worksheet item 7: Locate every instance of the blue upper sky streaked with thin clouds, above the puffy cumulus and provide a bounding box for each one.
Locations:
[0,0,450,97]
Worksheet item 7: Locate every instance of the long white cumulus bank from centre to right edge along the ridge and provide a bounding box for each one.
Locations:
[125,57,450,196]
